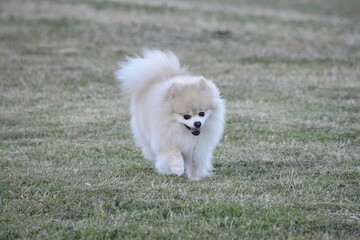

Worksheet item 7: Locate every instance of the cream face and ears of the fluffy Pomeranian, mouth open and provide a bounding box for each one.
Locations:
[168,79,213,136]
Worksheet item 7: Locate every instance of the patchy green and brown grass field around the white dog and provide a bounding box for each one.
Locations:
[0,0,360,239]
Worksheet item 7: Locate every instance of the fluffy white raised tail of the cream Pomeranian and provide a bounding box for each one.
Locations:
[116,50,186,93]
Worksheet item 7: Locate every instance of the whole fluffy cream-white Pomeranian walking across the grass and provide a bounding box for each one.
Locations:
[116,50,225,180]
